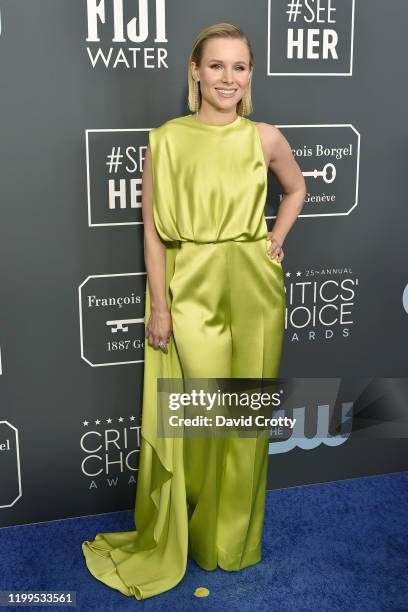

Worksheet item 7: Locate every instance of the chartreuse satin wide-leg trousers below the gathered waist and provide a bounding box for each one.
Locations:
[170,238,285,570]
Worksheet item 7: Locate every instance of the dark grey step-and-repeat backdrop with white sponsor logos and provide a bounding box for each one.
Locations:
[0,0,408,526]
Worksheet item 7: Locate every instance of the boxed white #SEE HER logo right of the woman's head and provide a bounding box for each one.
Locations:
[268,0,354,76]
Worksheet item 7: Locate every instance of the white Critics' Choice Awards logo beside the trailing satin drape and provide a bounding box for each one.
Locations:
[80,416,141,489]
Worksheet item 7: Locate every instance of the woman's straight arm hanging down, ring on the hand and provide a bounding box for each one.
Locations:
[142,145,172,353]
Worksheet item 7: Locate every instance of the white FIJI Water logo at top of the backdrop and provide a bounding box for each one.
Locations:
[86,0,168,69]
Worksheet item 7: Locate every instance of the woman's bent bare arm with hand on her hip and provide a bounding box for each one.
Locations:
[258,123,307,257]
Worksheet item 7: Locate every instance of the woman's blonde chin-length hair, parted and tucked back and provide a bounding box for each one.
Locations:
[187,23,254,116]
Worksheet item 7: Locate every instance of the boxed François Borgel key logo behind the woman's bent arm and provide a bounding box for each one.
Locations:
[265,125,360,219]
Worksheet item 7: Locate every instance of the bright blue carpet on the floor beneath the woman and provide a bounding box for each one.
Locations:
[0,472,408,612]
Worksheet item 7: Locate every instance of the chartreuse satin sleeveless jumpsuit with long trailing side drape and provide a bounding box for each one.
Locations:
[82,115,286,599]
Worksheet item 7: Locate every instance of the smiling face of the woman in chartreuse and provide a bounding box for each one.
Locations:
[192,38,250,111]
